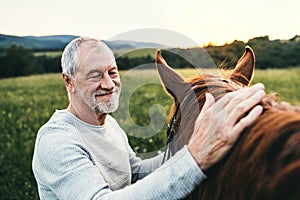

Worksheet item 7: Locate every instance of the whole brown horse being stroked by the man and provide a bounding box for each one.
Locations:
[156,47,300,200]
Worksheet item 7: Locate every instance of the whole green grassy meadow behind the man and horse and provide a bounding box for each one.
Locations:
[0,67,300,199]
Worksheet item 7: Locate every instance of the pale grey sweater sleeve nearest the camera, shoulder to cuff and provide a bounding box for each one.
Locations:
[33,127,205,200]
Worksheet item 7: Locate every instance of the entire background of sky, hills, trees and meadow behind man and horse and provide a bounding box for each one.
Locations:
[0,0,300,199]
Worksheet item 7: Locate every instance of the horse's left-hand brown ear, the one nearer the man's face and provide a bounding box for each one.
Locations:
[156,50,191,101]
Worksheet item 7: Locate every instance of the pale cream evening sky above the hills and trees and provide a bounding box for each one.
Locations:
[0,0,300,46]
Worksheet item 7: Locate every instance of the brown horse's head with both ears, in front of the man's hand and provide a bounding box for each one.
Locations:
[156,46,255,151]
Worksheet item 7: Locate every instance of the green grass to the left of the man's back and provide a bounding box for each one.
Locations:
[0,74,67,199]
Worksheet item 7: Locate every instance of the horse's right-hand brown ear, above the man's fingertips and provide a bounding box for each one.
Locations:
[230,46,255,86]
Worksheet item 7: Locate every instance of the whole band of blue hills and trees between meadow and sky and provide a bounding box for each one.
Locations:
[0,34,300,74]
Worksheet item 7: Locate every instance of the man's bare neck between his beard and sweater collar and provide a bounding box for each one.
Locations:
[67,104,107,126]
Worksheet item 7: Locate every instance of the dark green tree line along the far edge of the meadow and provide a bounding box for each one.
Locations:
[0,36,300,78]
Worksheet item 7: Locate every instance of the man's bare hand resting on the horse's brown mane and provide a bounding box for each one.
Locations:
[188,84,265,171]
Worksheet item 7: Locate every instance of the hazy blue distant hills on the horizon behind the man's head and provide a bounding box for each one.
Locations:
[0,34,165,51]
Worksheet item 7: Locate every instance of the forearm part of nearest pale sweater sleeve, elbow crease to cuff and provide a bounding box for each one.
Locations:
[99,146,206,200]
